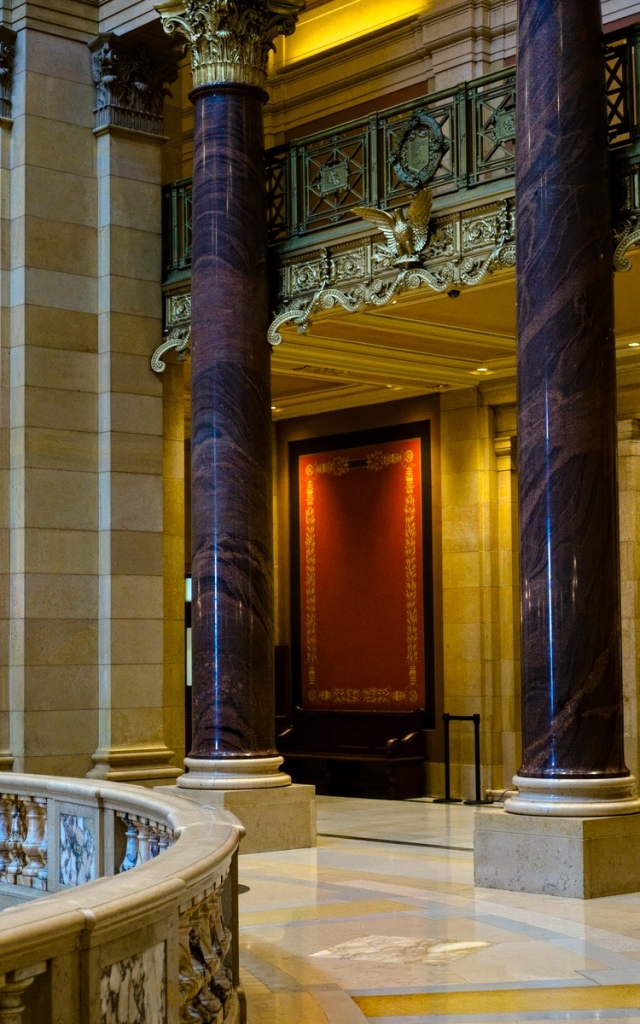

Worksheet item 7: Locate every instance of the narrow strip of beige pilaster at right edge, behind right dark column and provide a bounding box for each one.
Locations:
[617,419,640,778]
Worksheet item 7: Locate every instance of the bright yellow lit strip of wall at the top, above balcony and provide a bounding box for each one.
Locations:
[273,0,434,68]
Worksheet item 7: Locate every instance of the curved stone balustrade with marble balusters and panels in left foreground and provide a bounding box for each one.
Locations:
[0,773,245,1024]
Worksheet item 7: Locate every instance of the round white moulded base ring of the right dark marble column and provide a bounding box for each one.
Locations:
[505,775,640,818]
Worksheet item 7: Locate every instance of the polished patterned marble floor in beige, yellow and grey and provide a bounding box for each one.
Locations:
[240,797,640,1024]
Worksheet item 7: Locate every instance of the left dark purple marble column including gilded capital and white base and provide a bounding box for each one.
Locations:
[159,0,302,788]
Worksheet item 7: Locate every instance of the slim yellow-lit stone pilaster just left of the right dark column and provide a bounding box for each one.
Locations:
[494,433,522,790]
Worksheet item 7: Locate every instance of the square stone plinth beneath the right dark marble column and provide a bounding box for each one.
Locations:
[474,808,640,899]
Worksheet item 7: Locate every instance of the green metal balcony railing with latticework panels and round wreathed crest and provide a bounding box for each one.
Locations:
[165,25,640,282]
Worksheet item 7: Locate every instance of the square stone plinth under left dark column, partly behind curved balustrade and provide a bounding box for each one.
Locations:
[163,779,315,854]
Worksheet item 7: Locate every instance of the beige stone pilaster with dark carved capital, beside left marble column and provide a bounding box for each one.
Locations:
[84,36,183,785]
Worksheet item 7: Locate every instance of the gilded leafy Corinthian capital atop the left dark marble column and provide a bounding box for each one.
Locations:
[157,0,304,88]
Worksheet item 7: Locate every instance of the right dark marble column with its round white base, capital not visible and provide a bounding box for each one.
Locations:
[508,0,637,814]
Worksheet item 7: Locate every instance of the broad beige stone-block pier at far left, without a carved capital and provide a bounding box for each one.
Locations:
[8,28,98,775]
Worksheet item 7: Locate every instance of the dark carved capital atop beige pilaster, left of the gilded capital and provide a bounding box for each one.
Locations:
[89,35,178,135]
